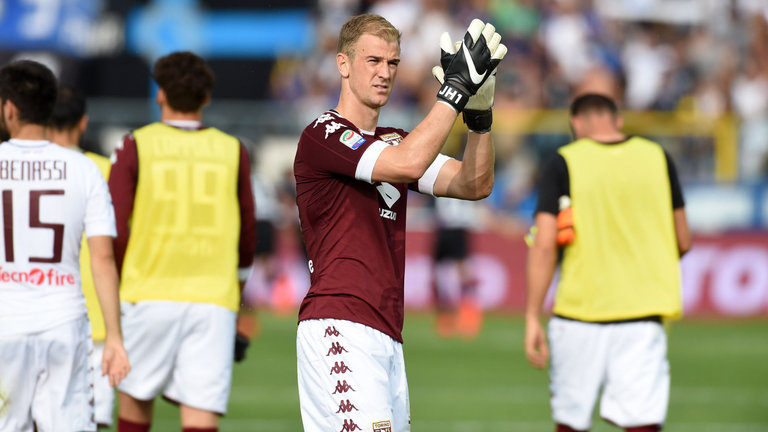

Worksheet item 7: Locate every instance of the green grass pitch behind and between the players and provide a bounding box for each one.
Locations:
[103,312,768,432]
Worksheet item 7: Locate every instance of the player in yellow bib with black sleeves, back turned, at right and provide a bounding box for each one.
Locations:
[525,94,691,432]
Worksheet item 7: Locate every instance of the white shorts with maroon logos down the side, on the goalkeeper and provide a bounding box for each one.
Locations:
[296,319,411,432]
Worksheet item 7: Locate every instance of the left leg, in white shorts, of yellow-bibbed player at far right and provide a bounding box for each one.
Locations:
[547,317,608,431]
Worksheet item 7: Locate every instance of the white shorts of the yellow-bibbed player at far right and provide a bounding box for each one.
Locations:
[548,317,669,430]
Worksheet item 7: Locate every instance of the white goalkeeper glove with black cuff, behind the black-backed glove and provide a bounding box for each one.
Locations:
[432,19,507,133]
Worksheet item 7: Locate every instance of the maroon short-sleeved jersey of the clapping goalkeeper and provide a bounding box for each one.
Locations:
[294,111,415,342]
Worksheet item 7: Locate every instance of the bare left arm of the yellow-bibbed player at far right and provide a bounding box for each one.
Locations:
[525,212,557,368]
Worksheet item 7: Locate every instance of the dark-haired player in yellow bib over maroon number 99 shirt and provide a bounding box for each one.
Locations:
[109,52,256,432]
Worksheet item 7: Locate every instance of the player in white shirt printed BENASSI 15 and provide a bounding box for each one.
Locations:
[0,61,130,432]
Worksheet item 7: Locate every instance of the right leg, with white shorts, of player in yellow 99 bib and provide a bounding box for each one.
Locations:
[163,303,237,431]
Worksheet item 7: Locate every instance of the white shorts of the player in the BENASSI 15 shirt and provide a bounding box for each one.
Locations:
[0,315,96,432]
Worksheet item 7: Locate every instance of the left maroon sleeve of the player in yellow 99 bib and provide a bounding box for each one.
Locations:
[109,134,139,272]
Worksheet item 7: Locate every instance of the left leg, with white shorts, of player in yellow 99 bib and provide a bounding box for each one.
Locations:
[118,301,184,432]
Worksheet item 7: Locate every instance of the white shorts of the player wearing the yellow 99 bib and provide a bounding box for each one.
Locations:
[118,301,237,414]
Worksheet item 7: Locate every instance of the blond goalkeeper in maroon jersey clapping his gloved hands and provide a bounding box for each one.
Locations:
[294,14,506,432]
